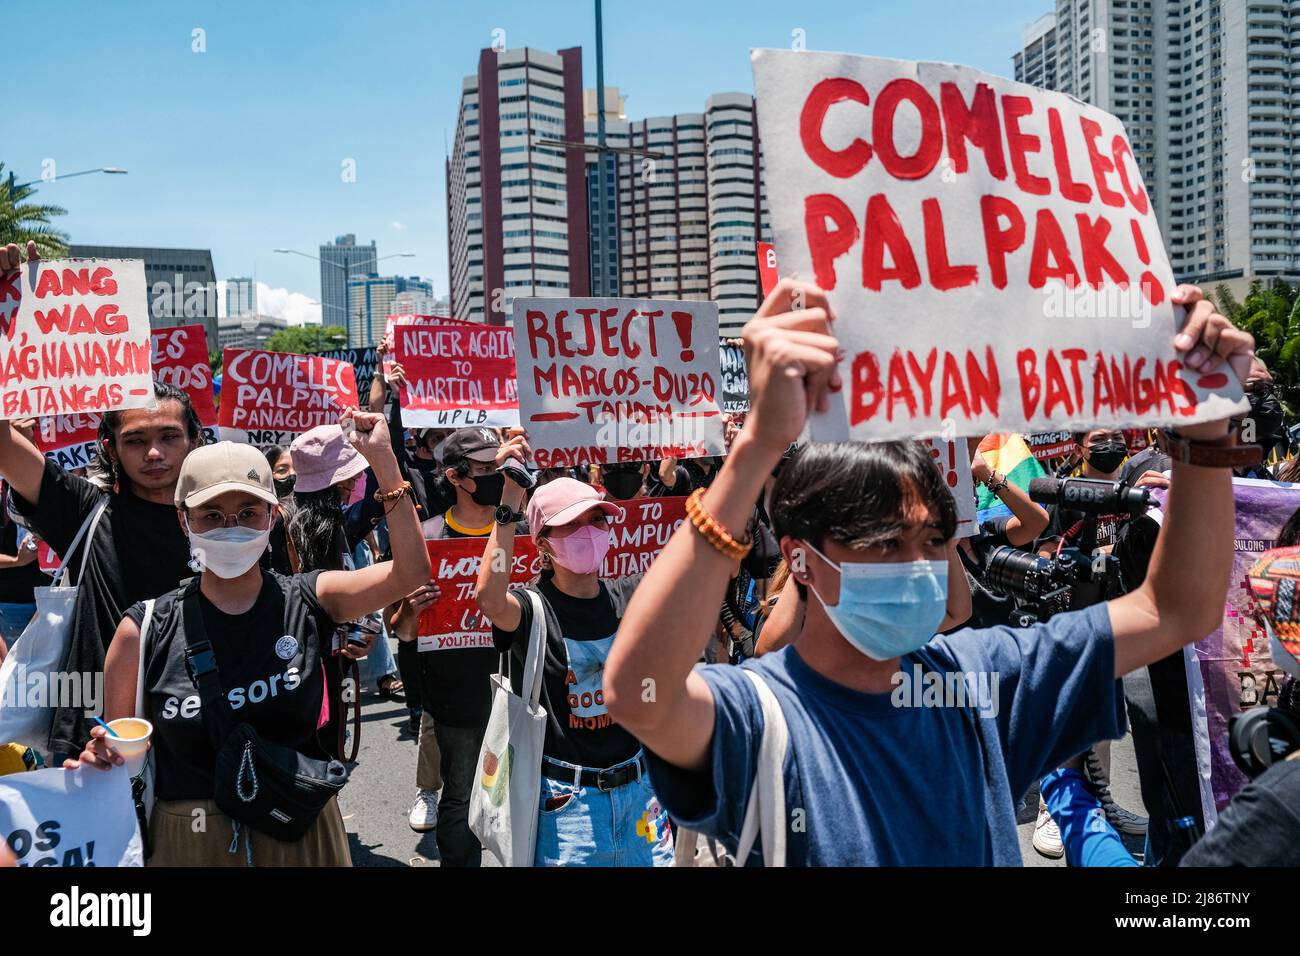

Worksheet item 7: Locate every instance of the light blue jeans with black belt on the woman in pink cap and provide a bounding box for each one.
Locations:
[534,761,672,866]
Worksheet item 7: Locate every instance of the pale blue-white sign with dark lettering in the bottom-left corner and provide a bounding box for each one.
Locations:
[0,767,144,866]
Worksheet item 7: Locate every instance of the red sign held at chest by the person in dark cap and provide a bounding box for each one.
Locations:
[417,536,542,650]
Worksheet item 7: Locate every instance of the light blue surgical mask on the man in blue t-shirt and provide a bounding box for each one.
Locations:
[809,545,948,661]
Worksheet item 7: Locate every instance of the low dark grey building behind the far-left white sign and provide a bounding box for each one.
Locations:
[68,243,217,349]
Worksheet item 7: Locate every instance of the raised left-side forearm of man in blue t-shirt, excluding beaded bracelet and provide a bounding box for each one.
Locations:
[605,434,781,731]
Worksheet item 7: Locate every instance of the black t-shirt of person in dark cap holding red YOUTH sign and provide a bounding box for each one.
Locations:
[420,509,501,727]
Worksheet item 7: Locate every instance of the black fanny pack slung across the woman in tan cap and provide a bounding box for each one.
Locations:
[178,579,348,842]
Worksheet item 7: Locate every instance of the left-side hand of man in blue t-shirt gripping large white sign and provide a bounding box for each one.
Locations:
[744,278,842,454]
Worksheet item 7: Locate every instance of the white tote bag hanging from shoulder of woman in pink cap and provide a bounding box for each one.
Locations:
[469,591,546,866]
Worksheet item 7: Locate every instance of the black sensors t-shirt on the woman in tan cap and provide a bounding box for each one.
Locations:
[127,571,335,800]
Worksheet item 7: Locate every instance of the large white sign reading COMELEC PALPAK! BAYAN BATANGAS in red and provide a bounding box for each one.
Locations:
[753,49,1247,440]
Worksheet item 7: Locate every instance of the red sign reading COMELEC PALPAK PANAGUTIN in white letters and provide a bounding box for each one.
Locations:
[220,349,358,447]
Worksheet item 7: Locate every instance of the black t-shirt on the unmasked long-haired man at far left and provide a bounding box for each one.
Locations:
[13,459,194,753]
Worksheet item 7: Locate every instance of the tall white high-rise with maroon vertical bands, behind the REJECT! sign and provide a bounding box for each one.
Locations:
[447,47,590,324]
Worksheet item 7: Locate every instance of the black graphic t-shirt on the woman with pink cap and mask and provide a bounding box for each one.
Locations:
[493,575,642,770]
